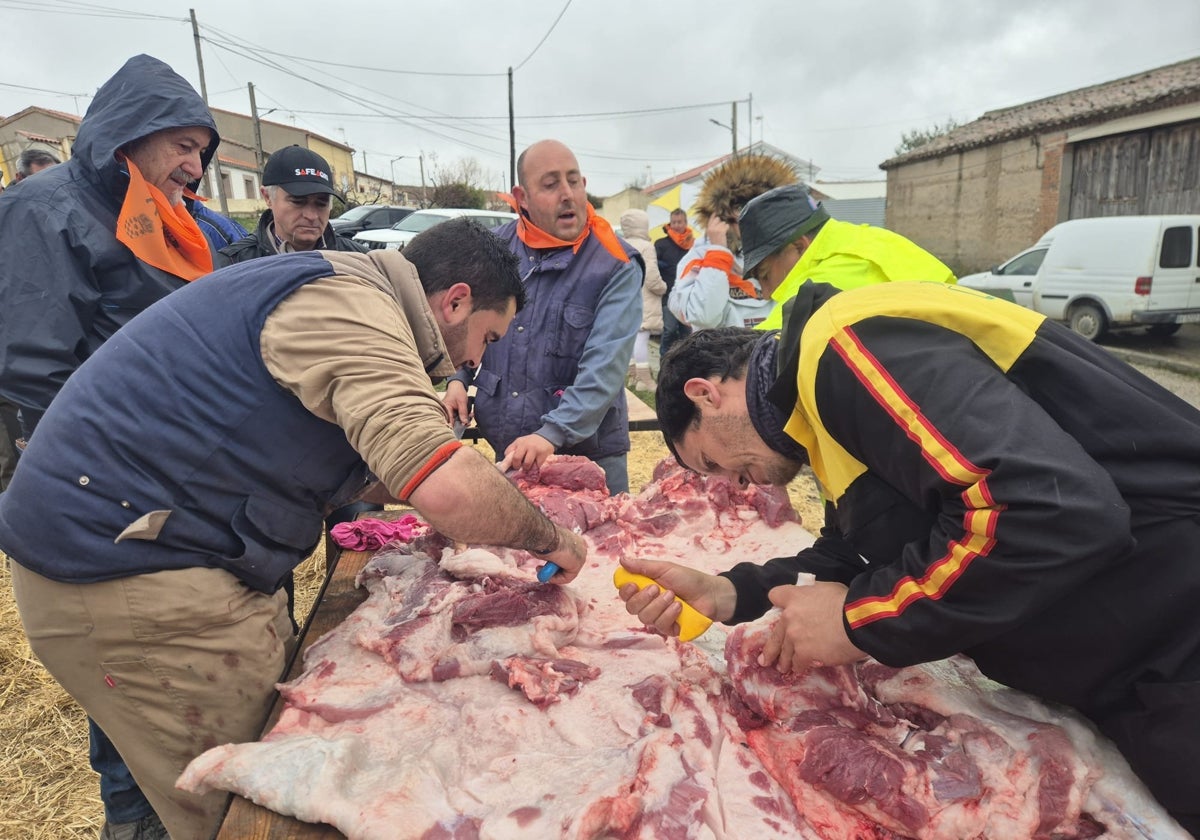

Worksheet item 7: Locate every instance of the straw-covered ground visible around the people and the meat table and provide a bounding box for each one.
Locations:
[0,432,822,840]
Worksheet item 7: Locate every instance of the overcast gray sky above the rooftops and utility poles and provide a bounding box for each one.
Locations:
[0,0,1200,196]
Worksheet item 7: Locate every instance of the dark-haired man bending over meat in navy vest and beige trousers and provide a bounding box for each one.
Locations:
[0,220,586,838]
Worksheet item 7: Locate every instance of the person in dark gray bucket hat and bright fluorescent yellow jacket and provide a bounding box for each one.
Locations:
[738,184,954,330]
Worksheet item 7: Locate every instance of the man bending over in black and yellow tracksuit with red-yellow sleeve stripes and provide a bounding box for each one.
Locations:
[623,282,1200,832]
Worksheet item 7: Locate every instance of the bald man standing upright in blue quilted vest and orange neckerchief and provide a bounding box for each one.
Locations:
[446,140,644,493]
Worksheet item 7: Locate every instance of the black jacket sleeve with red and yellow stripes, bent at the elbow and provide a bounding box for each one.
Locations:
[815,317,1134,665]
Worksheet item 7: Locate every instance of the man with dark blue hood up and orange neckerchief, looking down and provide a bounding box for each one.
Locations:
[0,55,220,838]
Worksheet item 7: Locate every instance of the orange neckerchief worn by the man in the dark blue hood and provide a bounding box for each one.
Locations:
[116,157,212,281]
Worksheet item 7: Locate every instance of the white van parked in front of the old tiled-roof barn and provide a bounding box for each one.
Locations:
[959,215,1200,341]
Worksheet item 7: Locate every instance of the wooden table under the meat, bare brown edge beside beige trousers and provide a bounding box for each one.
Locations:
[216,520,386,840]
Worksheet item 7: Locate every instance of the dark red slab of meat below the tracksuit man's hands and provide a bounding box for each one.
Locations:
[726,619,1186,840]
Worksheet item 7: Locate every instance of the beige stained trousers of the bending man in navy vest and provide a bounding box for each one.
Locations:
[8,562,294,840]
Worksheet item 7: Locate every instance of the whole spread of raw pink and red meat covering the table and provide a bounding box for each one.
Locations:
[179,458,1186,840]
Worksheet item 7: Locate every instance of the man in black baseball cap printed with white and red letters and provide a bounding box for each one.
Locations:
[217,145,366,268]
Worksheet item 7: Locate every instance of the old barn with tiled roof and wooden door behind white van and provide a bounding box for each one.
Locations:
[881,58,1200,276]
